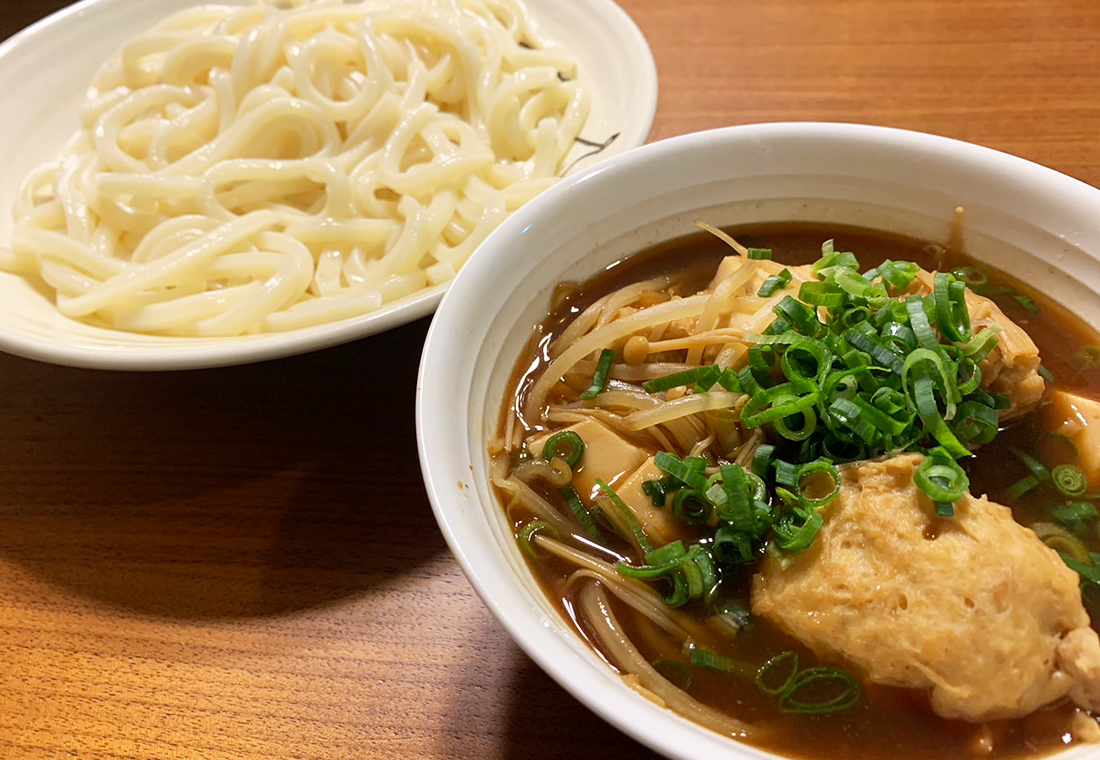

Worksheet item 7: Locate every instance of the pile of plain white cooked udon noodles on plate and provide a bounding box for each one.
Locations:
[0,0,592,337]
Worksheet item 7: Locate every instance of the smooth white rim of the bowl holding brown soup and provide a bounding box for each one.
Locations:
[416,121,1100,760]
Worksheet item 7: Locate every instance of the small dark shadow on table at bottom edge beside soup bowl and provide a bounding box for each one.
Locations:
[504,649,660,760]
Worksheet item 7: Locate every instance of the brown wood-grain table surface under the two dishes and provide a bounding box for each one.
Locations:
[0,0,1100,760]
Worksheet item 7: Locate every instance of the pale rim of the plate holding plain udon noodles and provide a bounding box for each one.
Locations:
[0,0,659,371]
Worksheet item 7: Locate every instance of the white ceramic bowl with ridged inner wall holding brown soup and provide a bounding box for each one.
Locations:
[417,123,1100,759]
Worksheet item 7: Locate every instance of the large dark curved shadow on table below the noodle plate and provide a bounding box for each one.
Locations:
[0,320,447,619]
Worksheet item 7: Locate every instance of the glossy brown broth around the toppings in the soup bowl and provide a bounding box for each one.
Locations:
[502,223,1100,760]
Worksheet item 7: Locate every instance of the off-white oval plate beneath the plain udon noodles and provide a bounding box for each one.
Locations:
[0,0,657,370]
